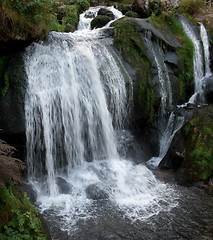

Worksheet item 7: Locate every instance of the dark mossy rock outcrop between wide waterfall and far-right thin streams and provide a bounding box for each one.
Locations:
[112,17,193,131]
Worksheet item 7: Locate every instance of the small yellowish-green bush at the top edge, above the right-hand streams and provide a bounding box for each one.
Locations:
[179,0,205,15]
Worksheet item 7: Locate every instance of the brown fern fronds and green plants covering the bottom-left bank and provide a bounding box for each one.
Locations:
[0,140,47,240]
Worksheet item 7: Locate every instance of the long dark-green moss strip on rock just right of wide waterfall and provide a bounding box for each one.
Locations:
[113,18,154,125]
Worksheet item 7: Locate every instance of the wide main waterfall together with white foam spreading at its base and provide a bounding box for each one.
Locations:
[25,6,176,238]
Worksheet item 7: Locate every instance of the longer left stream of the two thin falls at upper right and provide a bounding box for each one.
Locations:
[180,18,205,104]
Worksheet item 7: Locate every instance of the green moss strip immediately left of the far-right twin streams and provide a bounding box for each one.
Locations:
[150,14,194,102]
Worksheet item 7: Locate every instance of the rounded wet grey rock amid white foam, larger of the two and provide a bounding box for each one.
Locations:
[85,184,109,200]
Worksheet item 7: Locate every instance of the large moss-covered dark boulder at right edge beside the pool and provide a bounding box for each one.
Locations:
[159,105,213,184]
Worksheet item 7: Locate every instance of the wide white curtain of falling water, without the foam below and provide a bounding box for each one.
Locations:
[26,33,131,194]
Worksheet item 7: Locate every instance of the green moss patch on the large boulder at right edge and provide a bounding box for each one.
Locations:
[182,115,213,183]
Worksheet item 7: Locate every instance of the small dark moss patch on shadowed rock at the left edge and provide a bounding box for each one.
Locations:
[0,56,10,99]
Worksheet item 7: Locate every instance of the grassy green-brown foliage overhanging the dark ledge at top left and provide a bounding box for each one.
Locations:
[2,0,63,37]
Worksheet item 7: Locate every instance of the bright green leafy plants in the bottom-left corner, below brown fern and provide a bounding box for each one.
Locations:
[0,186,47,240]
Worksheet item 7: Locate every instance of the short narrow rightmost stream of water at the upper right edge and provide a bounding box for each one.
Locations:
[200,23,211,77]
